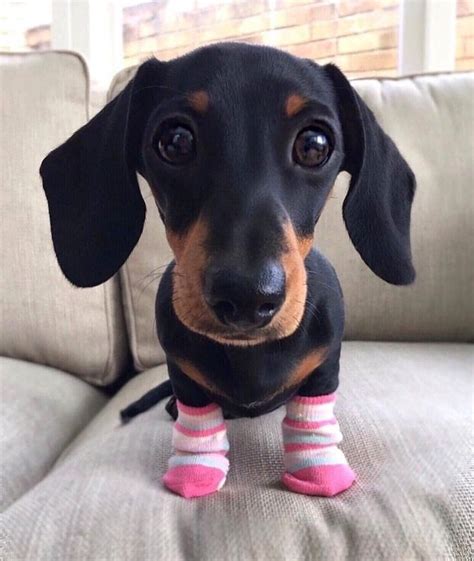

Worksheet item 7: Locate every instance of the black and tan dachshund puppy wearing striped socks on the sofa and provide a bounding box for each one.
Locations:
[41,43,415,497]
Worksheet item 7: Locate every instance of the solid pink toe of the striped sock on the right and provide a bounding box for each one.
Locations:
[282,464,356,497]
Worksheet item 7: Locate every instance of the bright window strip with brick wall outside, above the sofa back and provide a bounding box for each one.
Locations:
[0,0,474,89]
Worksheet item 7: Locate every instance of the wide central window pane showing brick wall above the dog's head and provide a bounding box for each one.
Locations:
[123,0,401,77]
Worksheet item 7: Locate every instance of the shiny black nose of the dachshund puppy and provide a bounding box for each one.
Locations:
[204,261,285,330]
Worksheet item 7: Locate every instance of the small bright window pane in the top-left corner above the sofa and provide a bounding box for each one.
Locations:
[0,0,51,51]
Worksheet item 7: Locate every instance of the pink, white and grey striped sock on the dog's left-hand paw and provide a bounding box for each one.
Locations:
[163,401,229,499]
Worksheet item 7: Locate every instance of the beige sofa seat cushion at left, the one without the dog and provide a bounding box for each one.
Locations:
[0,357,106,510]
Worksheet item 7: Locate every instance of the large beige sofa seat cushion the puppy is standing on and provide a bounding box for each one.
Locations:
[4,342,473,561]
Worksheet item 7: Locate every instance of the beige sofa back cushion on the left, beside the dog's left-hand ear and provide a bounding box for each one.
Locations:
[0,52,127,384]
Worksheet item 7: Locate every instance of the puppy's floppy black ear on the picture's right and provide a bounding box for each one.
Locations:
[324,64,415,285]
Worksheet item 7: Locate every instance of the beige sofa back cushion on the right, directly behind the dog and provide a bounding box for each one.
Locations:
[109,69,474,370]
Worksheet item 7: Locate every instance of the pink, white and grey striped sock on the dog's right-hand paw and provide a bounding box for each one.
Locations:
[283,393,355,497]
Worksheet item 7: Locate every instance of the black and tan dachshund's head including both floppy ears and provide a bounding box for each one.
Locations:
[41,44,415,344]
